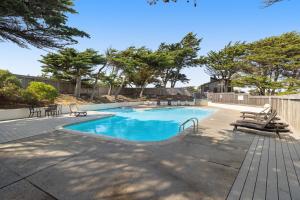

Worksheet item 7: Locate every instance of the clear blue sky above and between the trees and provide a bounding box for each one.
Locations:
[0,0,300,86]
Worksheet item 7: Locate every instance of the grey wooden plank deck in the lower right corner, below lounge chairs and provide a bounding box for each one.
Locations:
[227,136,300,200]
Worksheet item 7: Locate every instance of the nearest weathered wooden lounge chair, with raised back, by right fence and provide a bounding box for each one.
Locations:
[230,110,290,138]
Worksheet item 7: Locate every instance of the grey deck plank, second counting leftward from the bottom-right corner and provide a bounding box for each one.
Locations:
[276,138,291,200]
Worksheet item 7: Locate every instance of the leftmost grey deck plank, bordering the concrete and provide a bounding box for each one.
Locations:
[227,136,259,200]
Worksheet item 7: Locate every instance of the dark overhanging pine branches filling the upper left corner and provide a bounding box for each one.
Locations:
[0,0,89,48]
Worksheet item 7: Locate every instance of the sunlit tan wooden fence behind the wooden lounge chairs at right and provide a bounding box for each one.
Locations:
[207,93,300,134]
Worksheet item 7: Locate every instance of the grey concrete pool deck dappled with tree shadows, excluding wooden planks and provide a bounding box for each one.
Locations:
[0,109,298,200]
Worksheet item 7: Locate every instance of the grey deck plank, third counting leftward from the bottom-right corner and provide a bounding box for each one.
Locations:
[266,138,278,200]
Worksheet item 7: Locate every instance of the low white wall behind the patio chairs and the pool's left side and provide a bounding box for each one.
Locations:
[0,102,143,121]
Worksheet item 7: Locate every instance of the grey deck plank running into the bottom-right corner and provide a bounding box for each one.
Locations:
[282,140,300,199]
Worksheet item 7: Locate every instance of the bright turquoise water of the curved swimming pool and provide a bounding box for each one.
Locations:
[64,108,213,142]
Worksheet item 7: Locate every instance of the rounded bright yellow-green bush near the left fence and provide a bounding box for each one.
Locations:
[25,82,58,102]
